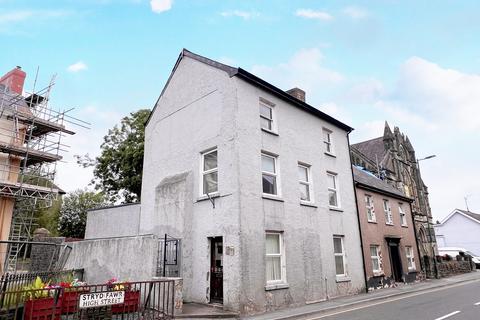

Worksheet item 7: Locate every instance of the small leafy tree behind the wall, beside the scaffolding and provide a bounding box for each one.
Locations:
[58,190,107,238]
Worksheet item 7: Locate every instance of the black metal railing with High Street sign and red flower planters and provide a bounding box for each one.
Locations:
[0,280,175,320]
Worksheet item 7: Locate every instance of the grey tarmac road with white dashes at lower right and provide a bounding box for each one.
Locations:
[303,281,480,320]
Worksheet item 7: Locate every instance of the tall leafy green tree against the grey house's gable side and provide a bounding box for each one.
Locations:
[76,109,150,203]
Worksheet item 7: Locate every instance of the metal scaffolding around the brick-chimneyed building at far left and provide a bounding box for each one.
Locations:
[0,77,88,272]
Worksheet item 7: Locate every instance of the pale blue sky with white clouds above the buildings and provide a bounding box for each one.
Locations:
[0,0,480,219]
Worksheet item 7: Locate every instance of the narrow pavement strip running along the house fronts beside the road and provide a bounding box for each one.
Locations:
[241,277,480,320]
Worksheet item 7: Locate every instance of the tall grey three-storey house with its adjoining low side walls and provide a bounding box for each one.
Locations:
[68,50,365,314]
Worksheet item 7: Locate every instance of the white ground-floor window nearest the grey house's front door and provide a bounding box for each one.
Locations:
[265,232,286,285]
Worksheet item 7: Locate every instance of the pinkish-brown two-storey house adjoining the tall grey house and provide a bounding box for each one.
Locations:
[353,166,420,290]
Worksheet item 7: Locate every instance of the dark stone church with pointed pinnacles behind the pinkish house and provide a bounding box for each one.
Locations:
[351,122,437,277]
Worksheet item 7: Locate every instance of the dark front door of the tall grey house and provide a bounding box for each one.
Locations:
[210,237,223,303]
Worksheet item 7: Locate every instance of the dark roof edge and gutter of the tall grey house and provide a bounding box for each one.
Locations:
[147,49,353,132]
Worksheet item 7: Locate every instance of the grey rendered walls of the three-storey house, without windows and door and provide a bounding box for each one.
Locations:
[139,51,365,314]
